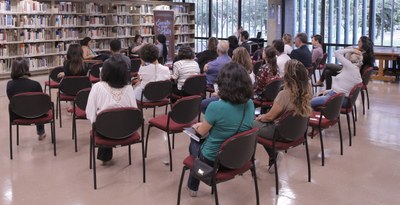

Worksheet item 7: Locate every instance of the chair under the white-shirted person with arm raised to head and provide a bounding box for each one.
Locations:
[340,83,363,146]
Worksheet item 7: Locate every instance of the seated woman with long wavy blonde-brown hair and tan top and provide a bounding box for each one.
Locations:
[254,60,312,173]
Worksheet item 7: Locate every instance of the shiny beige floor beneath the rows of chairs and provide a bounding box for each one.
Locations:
[0,76,400,205]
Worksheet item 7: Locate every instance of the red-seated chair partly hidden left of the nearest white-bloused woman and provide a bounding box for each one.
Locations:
[72,88,90,152]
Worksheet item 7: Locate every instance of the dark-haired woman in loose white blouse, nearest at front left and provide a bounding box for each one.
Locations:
[86,55,137,163]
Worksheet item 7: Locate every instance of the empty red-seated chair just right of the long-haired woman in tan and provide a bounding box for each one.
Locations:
[309,93,344,166]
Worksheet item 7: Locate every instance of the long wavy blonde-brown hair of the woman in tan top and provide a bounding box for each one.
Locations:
[283,59,312,116]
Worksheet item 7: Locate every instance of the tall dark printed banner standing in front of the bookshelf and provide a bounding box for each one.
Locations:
[153,10,175,60]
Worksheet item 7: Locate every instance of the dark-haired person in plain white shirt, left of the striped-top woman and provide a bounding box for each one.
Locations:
[135,44,171,102]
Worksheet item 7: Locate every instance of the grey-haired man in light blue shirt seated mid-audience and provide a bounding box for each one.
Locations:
[204,40,232,88]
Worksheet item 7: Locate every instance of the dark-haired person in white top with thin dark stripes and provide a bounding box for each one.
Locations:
[171,45,200,95]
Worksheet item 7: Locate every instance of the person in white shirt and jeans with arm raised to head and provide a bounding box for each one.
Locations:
[311,48,363,108]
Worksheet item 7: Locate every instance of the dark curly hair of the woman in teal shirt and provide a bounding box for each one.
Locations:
[217,62,253,104]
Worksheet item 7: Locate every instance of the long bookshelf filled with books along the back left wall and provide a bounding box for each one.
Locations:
[0,0,195,78]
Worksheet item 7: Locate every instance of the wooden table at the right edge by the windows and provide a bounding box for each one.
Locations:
[371,47,400,82]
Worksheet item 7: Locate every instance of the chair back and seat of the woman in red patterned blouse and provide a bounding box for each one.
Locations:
[253,78,283,111]
